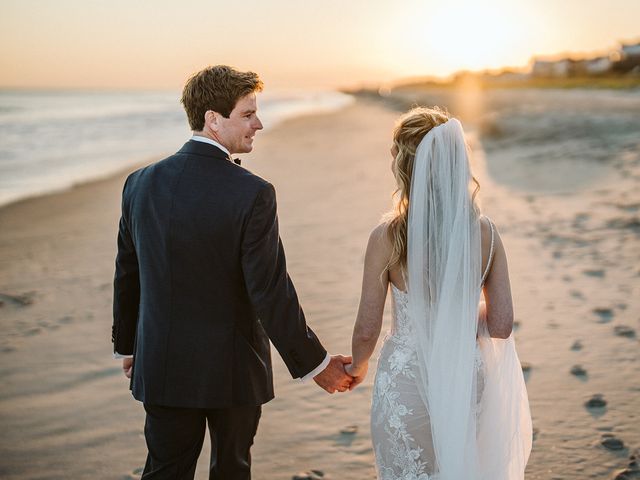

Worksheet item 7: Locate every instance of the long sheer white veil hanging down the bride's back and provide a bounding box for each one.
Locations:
[407,119,530,480]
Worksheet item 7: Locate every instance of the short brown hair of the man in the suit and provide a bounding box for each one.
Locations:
[180,65,263,132]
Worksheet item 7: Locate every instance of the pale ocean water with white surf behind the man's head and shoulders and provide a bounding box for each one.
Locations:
[0,90,353,206]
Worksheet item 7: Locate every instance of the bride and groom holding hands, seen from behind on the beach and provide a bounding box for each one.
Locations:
[112,66,531,480]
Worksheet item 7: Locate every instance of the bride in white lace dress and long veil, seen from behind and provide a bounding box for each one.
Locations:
[347,107,532,480]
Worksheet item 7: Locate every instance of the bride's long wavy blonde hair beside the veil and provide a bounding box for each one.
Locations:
[385,107,480,269]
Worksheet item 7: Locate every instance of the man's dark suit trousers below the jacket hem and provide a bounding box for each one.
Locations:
[142,404,262,480]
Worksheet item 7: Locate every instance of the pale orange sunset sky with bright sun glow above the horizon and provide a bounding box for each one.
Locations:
[0,0,640,89]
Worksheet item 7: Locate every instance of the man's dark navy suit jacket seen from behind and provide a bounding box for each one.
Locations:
[112,140,326,408]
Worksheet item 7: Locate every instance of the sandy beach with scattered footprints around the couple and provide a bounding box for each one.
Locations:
[0,92,640,480]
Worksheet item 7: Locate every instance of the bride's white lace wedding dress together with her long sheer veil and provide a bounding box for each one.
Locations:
[371,119,532,480]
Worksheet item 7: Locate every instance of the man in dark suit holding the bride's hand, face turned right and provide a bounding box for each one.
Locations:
[112,65,352,480]
